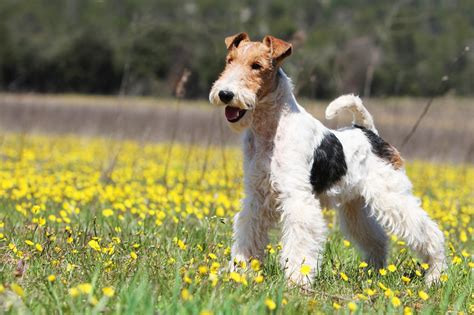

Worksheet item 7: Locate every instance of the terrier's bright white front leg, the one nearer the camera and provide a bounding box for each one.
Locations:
[280,192,326,287]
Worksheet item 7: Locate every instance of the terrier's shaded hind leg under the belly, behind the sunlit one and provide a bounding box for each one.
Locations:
[338,198,388,269]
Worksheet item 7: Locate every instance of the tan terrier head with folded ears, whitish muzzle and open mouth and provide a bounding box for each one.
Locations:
[209,33,292,131]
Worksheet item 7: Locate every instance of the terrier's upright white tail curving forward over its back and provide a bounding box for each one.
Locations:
[326,94,379,135]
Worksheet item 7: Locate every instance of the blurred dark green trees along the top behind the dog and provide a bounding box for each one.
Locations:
[0,0,474,98]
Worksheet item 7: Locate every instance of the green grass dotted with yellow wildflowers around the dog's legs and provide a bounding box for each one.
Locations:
[0,134,474,314]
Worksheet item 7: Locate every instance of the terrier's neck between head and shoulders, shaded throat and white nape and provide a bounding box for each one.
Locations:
[250,69,298,142]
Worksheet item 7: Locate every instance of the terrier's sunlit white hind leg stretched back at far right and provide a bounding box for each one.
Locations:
[364,166,446,284]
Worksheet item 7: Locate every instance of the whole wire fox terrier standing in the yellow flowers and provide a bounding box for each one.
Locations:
[209,33,446,286]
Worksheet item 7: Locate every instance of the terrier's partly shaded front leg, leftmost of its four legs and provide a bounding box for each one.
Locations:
[230,194,270,270]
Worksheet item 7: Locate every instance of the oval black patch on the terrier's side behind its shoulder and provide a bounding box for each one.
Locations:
[310,132,347,194]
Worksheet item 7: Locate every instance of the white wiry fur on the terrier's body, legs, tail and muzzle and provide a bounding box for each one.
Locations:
[210,70,446,285]
